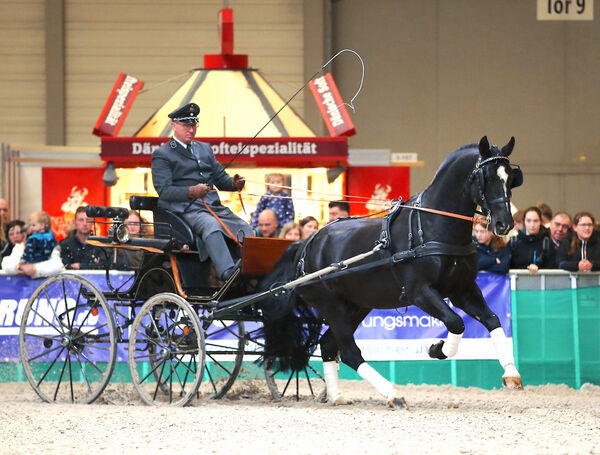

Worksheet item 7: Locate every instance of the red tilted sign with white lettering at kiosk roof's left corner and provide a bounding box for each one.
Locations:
[93,73,144,136]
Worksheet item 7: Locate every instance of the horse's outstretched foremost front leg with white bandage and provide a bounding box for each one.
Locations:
[450,284,523,389]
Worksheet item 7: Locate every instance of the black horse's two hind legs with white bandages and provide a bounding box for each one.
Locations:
[319,302,407,408]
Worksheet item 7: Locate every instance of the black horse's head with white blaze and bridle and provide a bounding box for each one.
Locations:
[466,136,523,235]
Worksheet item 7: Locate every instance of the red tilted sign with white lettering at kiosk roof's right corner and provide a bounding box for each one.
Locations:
[308,73,356,136]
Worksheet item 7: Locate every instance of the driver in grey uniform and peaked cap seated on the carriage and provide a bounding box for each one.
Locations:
[152,103,253,281]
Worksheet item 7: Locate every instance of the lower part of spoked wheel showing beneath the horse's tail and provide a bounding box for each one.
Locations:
[265,363,327,402]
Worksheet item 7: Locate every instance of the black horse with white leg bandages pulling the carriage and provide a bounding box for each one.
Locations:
[262,137,523,407]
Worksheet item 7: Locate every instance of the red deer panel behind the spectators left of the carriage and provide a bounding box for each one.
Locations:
[42,167,106,241]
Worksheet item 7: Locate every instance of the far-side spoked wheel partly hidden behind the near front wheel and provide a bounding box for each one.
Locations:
[199,319,246,399]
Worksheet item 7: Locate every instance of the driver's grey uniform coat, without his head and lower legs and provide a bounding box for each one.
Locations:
[152,138,253,260]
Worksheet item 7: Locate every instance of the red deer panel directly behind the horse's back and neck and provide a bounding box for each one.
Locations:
[348,166,410,215]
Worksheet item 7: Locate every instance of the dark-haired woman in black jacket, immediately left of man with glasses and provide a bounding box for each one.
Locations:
[509,207,555,274]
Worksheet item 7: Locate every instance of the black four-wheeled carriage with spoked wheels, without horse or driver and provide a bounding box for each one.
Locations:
[19,196,326,406]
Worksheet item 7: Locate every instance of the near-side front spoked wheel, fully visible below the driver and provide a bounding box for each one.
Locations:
[129,293,205,406]
